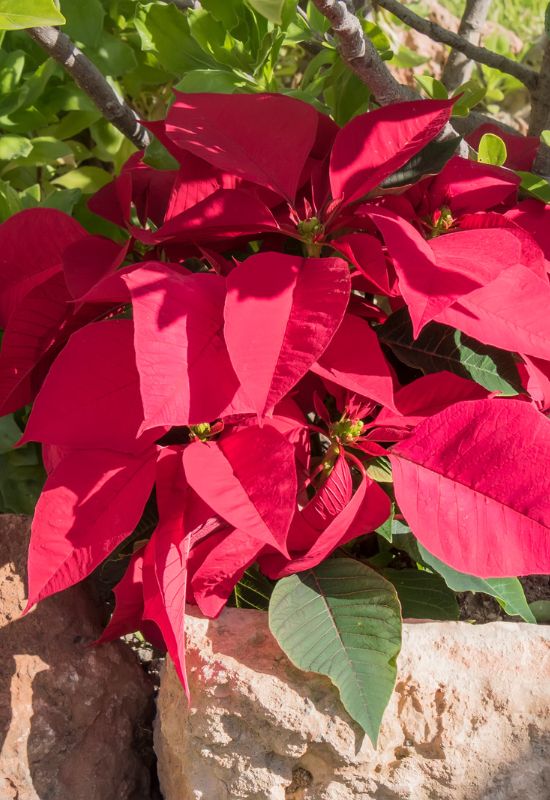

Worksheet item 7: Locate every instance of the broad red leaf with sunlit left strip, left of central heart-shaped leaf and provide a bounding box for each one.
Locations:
[124,263,242,429]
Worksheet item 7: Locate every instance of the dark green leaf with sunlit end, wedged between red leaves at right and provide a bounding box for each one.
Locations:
[377,309,522,397]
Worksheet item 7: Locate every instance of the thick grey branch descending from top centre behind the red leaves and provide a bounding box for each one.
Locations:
[313,0,469,158]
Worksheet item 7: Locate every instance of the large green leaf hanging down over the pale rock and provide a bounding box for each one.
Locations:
[269,558,401,746]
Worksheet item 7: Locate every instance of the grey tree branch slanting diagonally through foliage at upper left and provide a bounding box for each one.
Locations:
[27,27,151,150]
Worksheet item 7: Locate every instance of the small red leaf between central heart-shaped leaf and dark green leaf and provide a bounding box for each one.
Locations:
[311,314,394,408]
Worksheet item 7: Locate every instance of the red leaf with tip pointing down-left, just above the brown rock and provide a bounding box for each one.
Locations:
[27,448,156,608]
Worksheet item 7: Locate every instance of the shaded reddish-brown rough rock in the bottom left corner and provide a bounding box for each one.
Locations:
[0,515,152,800]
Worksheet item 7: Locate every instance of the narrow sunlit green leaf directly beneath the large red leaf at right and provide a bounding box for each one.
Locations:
[417,542,536,622]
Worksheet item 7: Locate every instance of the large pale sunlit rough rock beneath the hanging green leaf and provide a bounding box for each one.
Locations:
[155,609,550,800]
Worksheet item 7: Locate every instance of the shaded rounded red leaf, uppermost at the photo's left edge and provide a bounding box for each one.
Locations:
[0,208,88,328]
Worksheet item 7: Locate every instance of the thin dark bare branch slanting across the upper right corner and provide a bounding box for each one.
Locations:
[376,0,538,91]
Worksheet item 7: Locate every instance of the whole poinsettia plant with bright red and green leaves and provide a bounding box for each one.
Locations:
[0,94,550,740]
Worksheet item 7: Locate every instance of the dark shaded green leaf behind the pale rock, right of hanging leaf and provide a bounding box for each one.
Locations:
[382,569,458,620]
